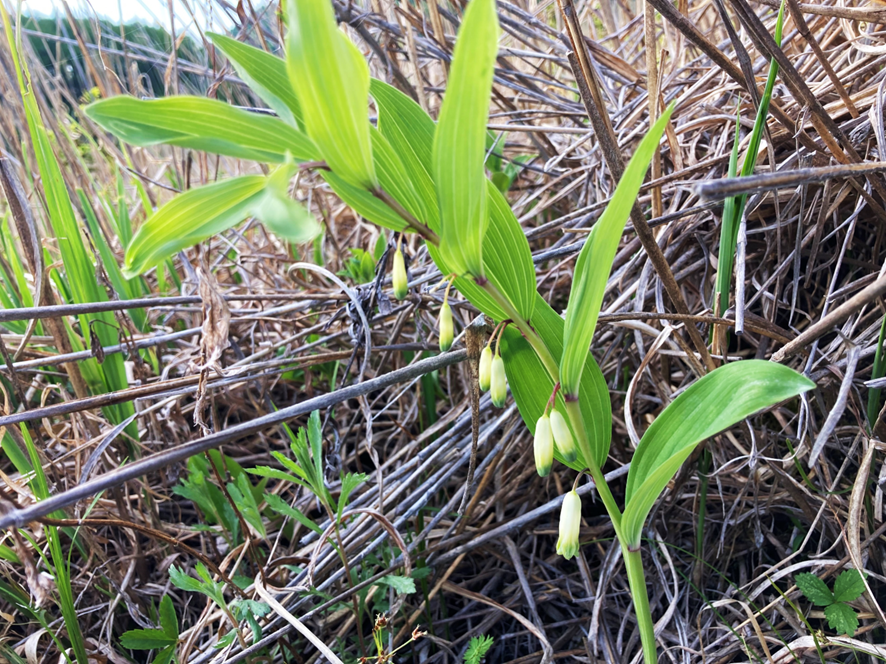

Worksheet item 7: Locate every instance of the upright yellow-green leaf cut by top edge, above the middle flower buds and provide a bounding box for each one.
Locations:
[433,0,498,277]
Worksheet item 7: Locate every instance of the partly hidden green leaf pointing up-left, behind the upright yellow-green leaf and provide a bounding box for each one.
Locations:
[206,32,303,127]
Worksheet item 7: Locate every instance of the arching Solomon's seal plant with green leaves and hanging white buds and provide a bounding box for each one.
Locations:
[86,0,813,664]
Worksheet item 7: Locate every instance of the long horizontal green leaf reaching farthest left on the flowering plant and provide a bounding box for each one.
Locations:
[84,96,319,163]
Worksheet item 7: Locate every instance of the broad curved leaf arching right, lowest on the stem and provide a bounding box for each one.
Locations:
[622,360,815,547]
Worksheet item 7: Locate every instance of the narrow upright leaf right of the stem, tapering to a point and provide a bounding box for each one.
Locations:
[560,106,673,396]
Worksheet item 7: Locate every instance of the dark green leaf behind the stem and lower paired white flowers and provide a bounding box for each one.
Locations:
[501,294,612,471]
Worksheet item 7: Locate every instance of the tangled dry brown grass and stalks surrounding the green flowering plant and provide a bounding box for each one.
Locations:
[0,0,886,664]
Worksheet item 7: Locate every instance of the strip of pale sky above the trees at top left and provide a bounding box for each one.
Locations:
[23,0,231,33]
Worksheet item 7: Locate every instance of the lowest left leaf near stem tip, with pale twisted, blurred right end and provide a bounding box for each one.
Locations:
[123,170,320,277]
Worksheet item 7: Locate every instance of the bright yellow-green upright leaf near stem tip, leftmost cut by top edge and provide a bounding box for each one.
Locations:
[286,0,378,189]
